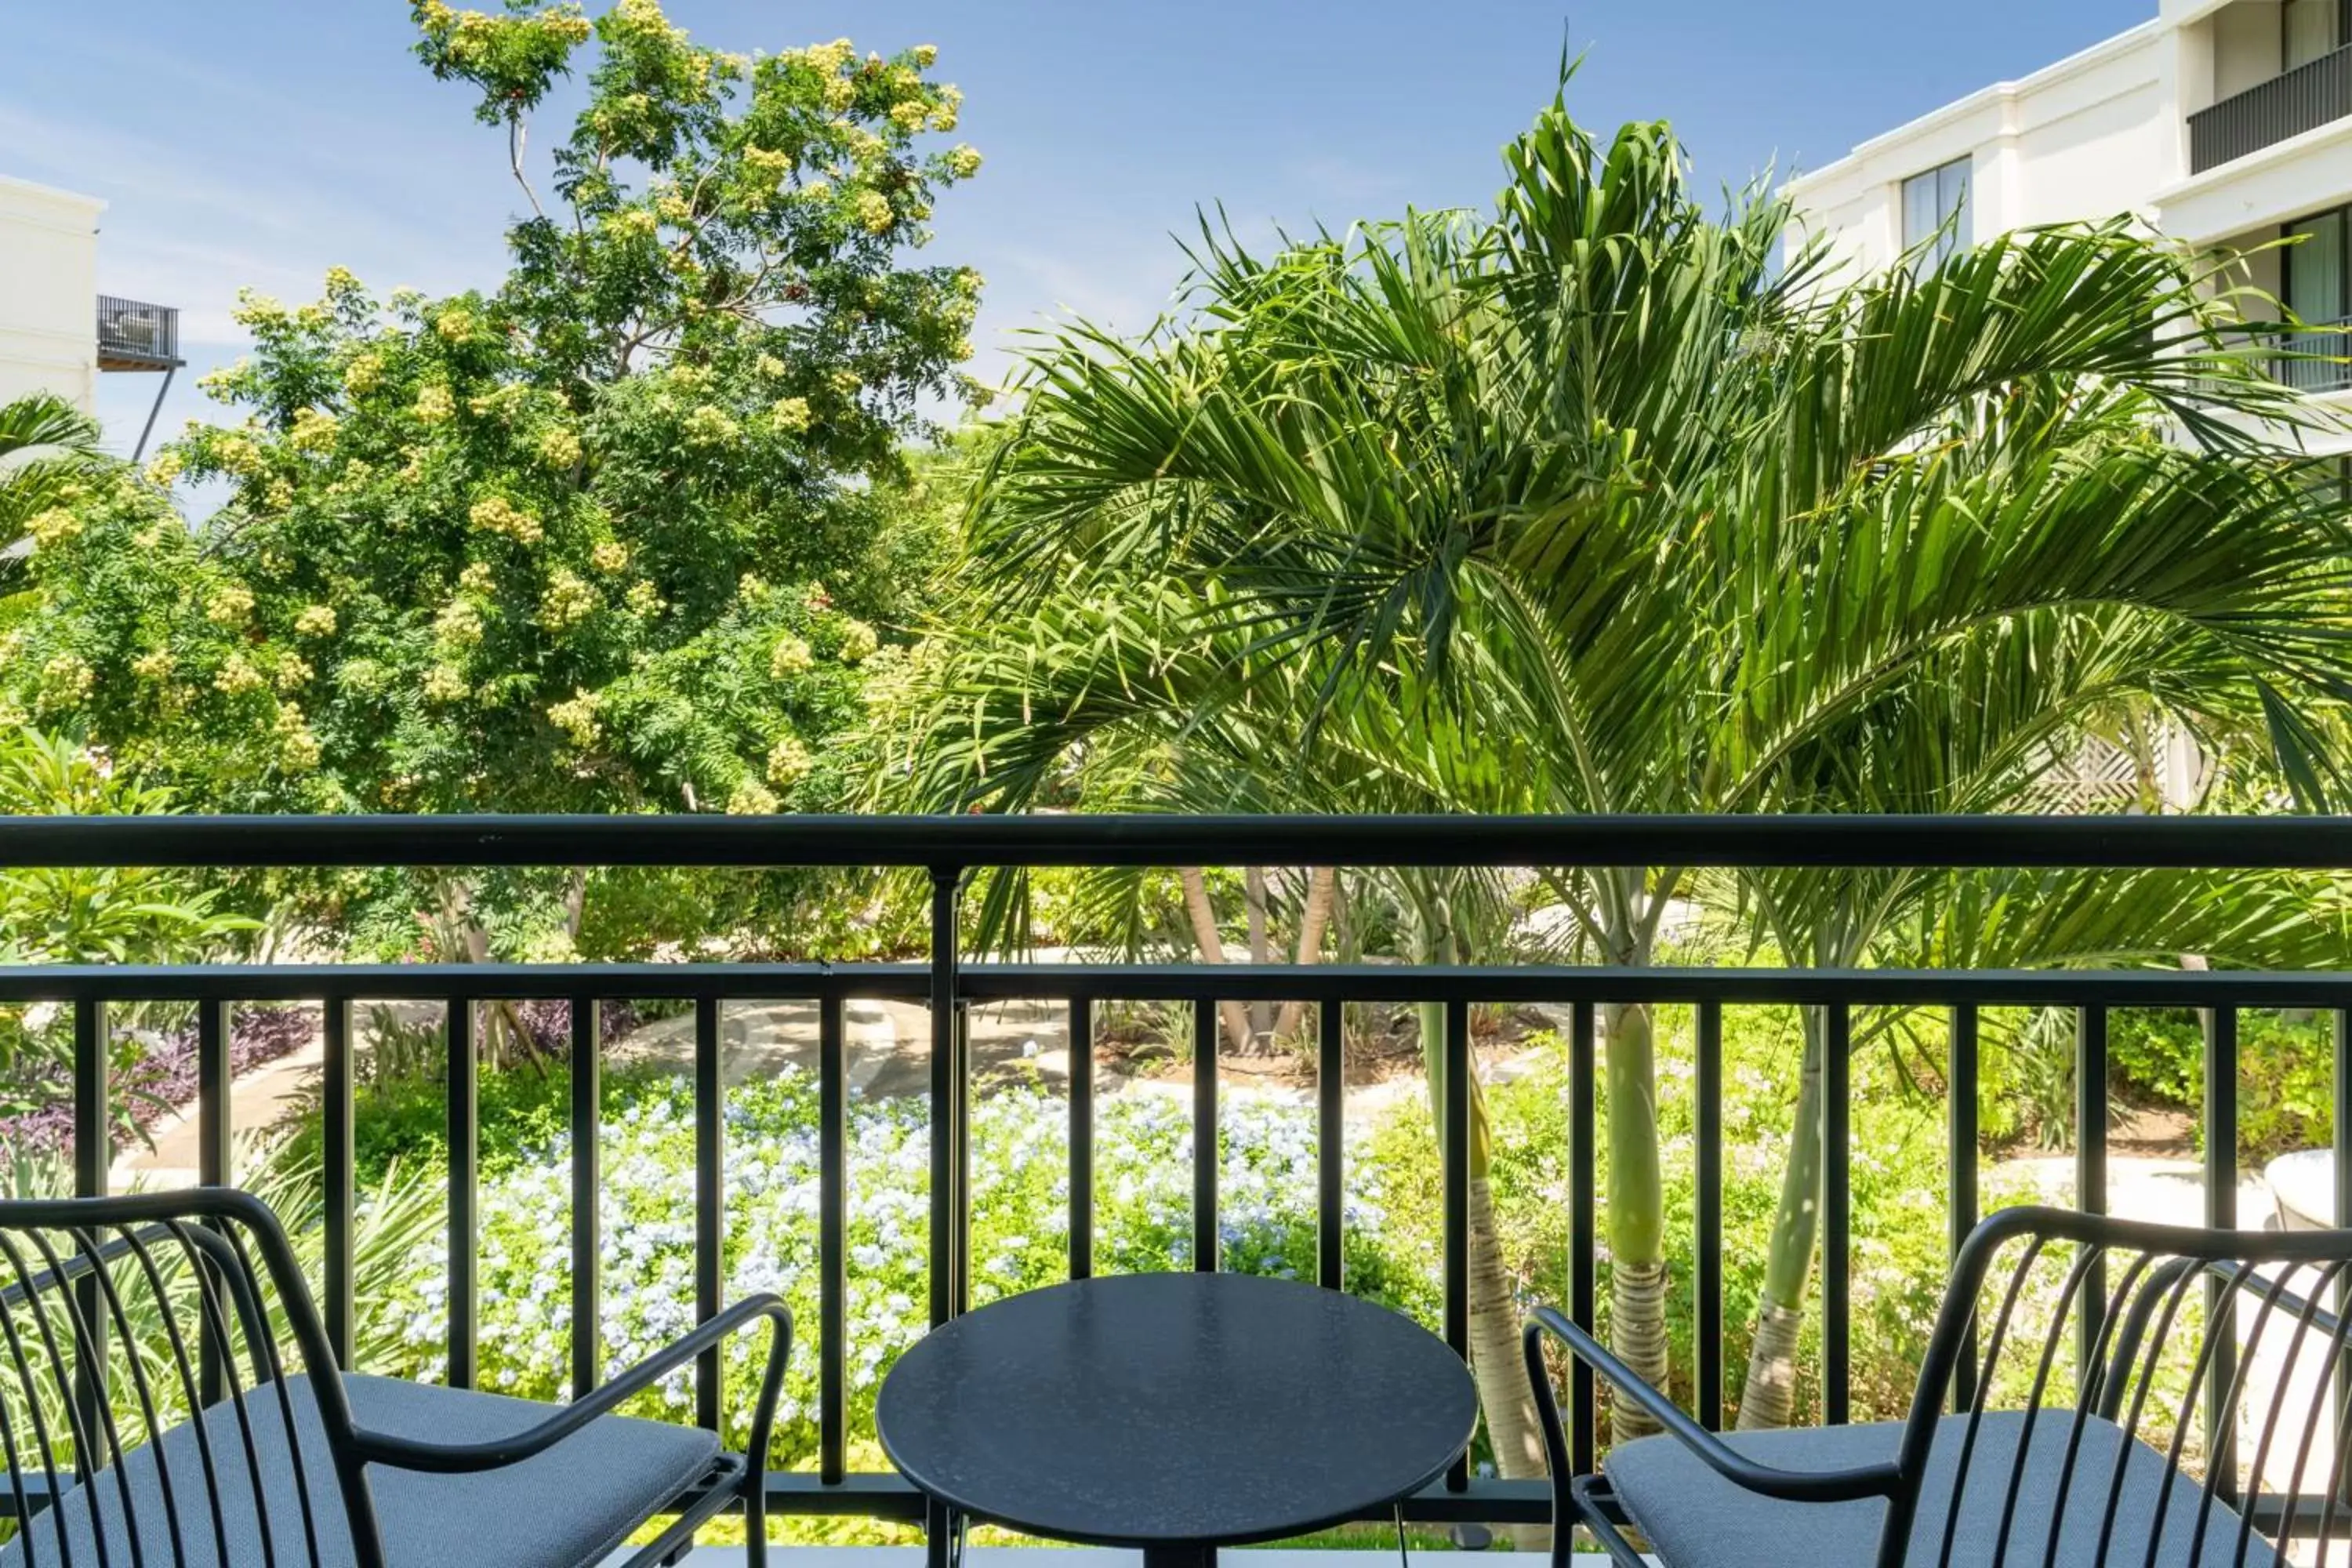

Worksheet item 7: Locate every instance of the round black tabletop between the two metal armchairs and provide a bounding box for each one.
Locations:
[875,1274,1477,1568]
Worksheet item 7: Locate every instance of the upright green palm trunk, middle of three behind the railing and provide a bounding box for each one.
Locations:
[1576,1004,1668,1443]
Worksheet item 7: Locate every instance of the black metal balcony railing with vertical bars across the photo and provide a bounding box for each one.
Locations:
[0,815,2352,1561]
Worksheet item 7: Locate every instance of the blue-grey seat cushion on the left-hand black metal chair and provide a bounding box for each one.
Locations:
[0,1375,720,1568]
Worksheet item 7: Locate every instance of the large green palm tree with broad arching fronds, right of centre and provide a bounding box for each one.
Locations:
[884,101,2352,1436]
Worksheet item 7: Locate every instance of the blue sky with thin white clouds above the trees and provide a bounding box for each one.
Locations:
[0,0,2154,449]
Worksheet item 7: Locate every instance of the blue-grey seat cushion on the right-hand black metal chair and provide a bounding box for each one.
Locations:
[1604,1410,2281,1568]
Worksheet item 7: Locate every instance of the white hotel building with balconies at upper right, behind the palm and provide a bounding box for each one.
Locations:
[1788,0,2352,452]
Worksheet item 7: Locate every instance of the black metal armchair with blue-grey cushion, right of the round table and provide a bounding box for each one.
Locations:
[1524,1208,2352,1568]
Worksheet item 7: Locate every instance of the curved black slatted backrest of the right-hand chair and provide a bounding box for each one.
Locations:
[1879,1208,2352,1568]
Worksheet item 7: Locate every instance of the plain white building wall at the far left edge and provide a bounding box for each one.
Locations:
[0,176,106,414]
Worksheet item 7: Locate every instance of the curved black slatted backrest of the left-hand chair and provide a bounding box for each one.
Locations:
[0,1187,383,1568]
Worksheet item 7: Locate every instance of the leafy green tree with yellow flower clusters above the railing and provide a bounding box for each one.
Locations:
[0,0,978,846]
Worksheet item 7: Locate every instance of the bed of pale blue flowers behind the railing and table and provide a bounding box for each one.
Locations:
[376,1069,1439,1467]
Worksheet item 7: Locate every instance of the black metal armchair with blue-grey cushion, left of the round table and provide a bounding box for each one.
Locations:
[0,1187,793,1568]
